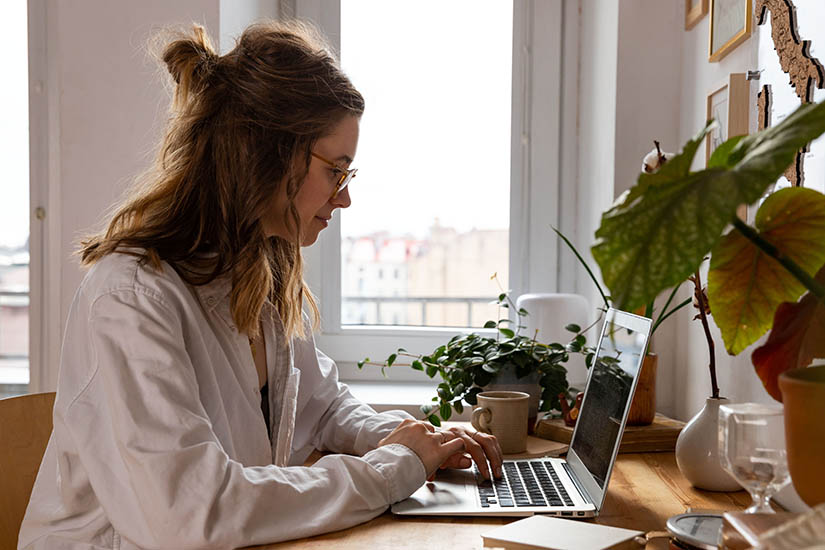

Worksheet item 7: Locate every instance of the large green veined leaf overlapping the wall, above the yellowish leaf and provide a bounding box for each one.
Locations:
[592,103,825,310]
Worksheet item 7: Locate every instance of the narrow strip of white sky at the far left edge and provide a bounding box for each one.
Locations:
[0,0,29,250]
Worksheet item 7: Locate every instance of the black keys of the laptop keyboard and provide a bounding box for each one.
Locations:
[473,460,573,508]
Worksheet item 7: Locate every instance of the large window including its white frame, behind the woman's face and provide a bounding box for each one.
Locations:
[294,0,563,380]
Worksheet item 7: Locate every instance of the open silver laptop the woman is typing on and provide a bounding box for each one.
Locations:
[392,308,651,518]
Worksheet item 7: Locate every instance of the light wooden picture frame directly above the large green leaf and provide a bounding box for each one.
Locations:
[705,73,751,221]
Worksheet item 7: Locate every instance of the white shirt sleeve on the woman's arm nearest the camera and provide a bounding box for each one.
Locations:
[67,289,426,549]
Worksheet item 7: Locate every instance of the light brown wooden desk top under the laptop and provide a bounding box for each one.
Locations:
[255,453,751,550]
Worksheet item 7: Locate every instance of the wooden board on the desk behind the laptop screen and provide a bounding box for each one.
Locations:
[536,413,685,453]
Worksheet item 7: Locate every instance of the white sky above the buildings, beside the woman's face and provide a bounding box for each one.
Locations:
[341,0,513,237]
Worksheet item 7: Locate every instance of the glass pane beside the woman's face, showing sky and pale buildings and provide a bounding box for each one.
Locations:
[340,0,513,327]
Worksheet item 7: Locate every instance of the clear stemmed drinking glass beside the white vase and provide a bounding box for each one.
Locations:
[719,403,790,514]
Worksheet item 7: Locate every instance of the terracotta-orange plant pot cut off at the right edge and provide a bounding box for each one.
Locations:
[779,366,825,506]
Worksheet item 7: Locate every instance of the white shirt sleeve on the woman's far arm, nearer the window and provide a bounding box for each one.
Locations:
[293,338,414,461]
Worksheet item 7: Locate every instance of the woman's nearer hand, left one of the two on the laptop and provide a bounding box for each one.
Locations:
[378,419,466,479]
